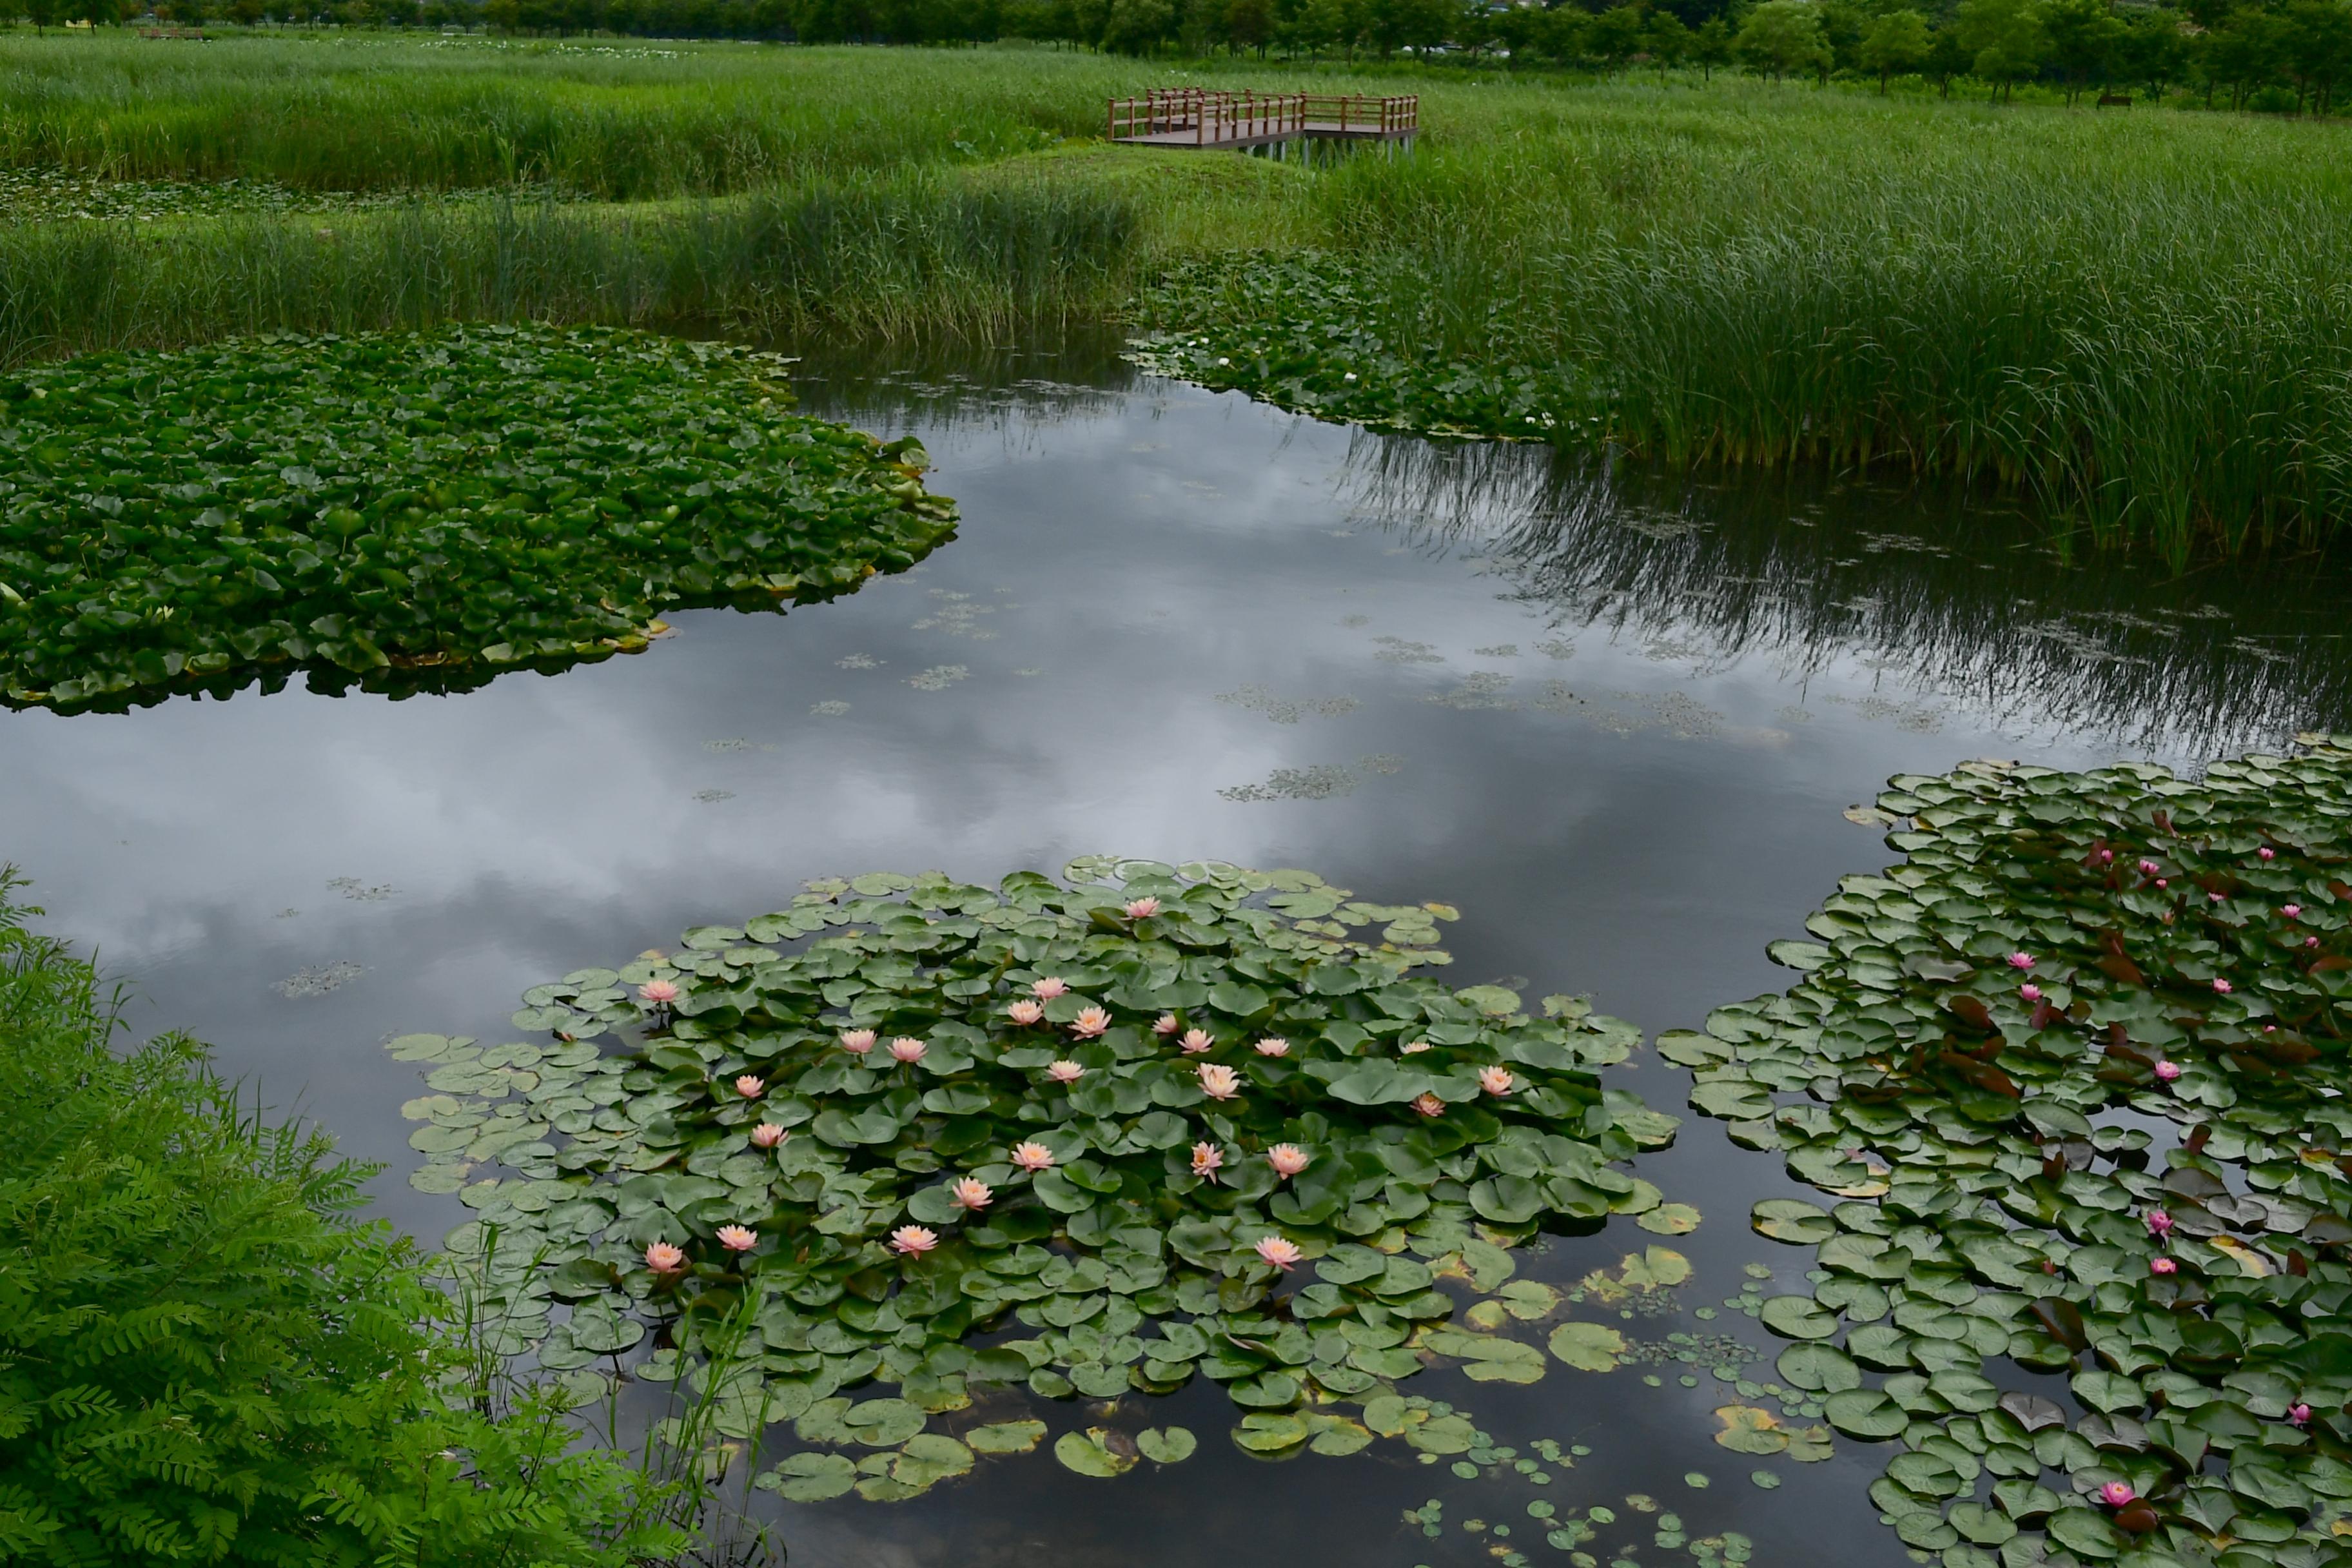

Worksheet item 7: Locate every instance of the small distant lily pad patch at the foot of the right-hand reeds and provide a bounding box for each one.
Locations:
[1129,251,1604,440]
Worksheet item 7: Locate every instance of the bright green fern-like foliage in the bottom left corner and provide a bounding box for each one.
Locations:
[0,870,685,1568]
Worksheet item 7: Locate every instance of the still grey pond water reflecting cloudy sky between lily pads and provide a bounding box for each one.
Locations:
[0,346,2352,1568]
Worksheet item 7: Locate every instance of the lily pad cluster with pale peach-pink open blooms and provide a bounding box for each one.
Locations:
[393,858,1689,1500]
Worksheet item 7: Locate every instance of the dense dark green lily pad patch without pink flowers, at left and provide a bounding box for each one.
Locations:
[0,327,952,707]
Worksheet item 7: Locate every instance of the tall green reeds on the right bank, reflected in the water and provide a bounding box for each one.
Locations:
[1315,99,2352,562]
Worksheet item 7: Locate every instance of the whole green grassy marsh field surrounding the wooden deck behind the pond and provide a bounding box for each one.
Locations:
[0,35,2352,560]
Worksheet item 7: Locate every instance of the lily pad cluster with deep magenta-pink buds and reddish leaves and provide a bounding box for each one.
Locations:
[1660,736,2352,1568]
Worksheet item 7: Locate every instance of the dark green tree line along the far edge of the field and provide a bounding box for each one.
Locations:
[27,0,2352,115]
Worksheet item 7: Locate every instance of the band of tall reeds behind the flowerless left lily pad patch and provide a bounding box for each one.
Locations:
[0,174,1136,364]
